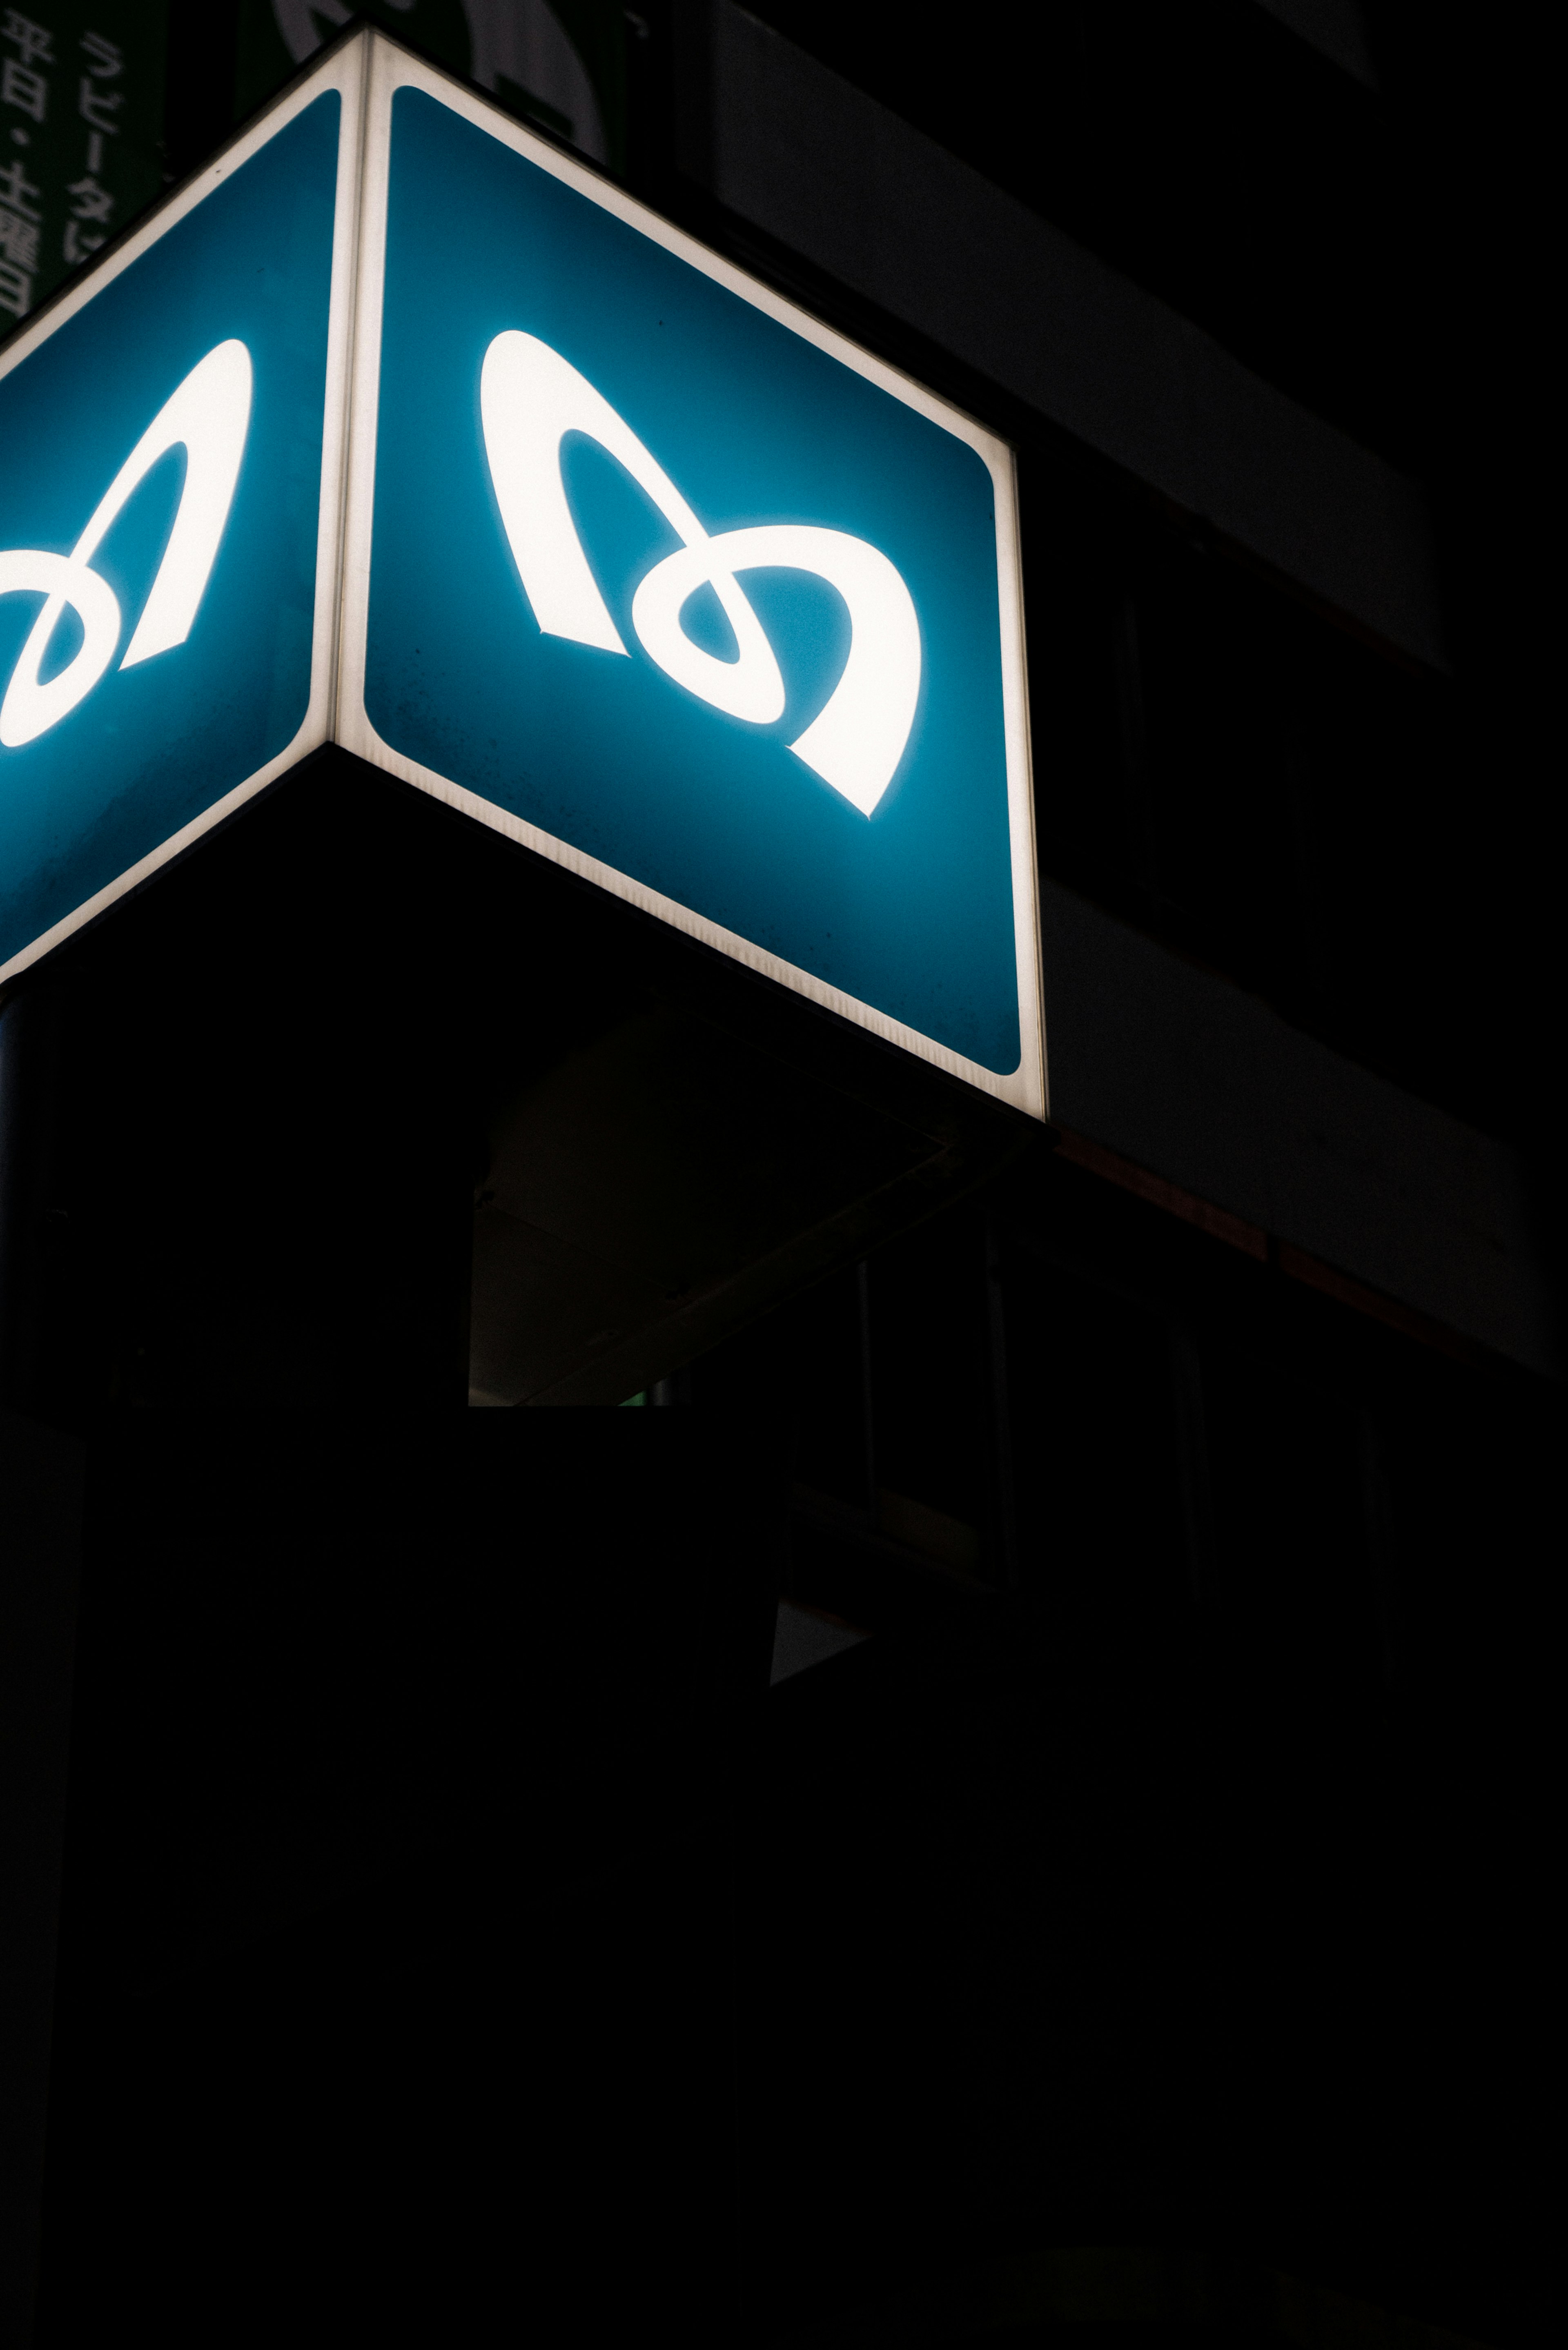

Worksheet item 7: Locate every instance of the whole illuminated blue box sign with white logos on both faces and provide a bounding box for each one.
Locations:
[0,33,1046,1116]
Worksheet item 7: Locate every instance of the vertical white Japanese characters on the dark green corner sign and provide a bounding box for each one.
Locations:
[0,7,150,317]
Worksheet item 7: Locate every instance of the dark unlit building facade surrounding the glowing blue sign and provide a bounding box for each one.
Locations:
[0,13,1561,2350]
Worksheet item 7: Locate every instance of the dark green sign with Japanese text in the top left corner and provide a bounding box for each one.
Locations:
[0,0,169,331]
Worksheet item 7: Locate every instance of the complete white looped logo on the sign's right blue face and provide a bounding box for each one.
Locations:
[479,329,919,815]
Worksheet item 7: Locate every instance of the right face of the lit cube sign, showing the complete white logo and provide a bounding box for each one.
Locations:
[343,47,1044,1109]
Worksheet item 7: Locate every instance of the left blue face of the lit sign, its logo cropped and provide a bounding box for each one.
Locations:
[0,48,357,971]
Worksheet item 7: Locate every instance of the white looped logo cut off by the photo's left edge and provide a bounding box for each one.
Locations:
[0,343,252,750]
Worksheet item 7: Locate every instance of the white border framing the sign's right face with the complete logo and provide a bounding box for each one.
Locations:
[334,31,1049,1118]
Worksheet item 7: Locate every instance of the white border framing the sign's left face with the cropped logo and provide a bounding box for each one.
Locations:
[0,40,367,985]
